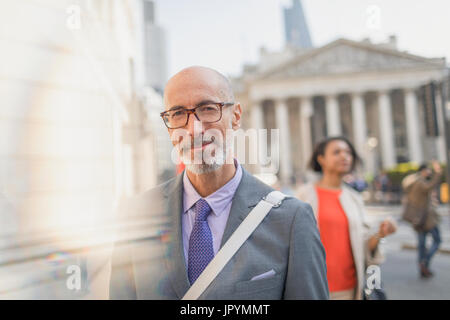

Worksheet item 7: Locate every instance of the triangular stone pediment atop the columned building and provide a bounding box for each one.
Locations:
[258,39,445,79]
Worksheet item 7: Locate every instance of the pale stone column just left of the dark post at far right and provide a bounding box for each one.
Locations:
[404,88,423,164]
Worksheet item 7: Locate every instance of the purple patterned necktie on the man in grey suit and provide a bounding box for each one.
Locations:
[188,199,214,284]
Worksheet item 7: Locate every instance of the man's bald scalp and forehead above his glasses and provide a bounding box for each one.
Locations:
[164,66,234,109]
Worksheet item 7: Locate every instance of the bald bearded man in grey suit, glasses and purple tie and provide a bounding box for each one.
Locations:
[110,67,328,299]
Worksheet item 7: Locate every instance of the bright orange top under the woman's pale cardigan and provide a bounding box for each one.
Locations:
[316,186,356,292]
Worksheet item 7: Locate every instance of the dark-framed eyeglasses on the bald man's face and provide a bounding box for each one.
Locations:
[160,101,234,129]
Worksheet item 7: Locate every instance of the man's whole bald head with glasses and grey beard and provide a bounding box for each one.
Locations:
[163,66,242,175]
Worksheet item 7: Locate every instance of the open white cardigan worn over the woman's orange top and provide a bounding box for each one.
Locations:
[298,183,384,299]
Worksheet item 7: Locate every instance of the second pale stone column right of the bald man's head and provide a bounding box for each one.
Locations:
[275,100,292,184]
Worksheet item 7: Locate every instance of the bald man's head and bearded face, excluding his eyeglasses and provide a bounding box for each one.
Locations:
[165,70,241,174]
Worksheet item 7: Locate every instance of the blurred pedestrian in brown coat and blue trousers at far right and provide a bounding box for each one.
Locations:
[403,161,442,278]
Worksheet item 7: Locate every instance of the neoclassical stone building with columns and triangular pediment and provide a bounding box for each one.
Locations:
[233,36,449,183]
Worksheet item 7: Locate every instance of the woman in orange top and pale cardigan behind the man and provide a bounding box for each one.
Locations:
[298,137,396,300]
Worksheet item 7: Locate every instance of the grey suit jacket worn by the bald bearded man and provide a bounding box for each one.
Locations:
[110,170,328,299]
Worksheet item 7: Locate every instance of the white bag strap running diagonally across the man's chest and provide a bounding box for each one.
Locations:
[182,191,287,300]
